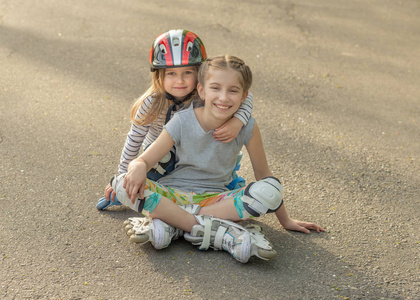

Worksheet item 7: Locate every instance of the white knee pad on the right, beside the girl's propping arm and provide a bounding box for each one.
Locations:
[242,177,283,217]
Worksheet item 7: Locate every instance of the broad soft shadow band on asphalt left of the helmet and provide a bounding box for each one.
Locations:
[0,24,144,102]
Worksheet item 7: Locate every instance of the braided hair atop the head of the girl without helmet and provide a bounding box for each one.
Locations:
[198,55,252,92]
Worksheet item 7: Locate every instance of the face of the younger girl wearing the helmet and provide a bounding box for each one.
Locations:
[163,66,197,101]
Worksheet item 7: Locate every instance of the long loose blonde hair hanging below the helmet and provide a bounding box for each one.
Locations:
[131,66,199,126]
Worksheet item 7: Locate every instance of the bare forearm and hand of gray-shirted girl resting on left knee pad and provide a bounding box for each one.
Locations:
[123,129,175,203]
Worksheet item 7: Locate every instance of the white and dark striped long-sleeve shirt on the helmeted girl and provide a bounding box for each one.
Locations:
[118,92,253,174]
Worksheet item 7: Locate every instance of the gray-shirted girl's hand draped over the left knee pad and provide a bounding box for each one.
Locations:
[123,160,147,204]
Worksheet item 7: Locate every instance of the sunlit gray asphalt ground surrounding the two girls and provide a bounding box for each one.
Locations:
[0,0,420,299]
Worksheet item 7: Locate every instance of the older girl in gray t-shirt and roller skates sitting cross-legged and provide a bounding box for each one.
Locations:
[111,56,324,262]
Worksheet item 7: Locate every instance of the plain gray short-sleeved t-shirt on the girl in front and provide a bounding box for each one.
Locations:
[159,105,255,194]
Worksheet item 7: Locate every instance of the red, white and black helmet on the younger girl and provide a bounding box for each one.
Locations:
[149,29,207,71]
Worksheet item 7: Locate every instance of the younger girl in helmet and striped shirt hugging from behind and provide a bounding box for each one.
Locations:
[96,29,252,210]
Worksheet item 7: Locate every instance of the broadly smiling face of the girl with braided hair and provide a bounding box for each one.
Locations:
[197,67,248,121]
